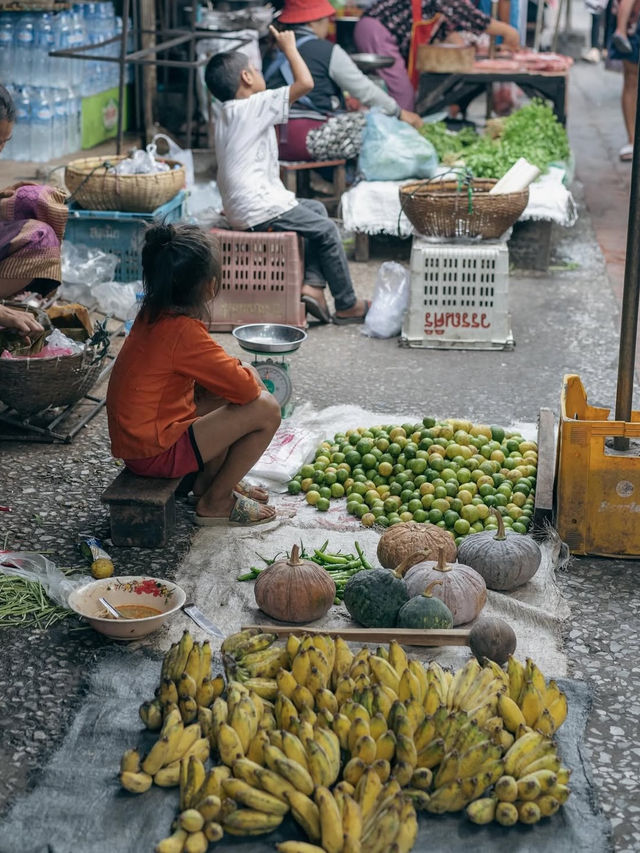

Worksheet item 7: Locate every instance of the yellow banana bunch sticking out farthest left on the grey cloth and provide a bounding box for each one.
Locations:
[119,707,209,794]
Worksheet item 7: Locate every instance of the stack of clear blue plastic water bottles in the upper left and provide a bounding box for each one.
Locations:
[0,0,133,162]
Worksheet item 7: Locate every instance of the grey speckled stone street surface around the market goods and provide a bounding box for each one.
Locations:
[0,20,640,853]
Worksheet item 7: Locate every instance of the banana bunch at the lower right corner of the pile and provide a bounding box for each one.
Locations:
[467,729,571,826]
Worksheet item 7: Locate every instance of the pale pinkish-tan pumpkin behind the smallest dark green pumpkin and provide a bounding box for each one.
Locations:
[396,548,487,625]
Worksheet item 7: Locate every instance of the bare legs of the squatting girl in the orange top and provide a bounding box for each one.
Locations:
[193,391,280,519]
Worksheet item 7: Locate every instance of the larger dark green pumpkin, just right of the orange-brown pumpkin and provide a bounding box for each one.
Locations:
[343,569,409,628]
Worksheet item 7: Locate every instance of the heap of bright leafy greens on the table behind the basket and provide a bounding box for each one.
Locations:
[420,98,569,178]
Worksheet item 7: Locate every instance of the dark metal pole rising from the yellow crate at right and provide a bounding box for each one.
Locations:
[613,66,640,450]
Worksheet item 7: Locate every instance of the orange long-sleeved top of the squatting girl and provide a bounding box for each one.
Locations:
[107,314,260,459]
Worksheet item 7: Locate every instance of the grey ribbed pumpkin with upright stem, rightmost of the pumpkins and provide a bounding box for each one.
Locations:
[458,508,542,590]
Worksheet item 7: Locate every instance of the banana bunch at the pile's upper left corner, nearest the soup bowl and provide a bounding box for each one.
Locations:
[139,631,224,731]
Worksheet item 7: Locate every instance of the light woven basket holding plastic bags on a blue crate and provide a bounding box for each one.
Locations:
[64,156,185,213]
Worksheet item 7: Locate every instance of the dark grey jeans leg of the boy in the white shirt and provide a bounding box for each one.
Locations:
[254,199,368,319]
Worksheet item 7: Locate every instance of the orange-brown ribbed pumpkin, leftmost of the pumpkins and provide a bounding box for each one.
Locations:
[254,545,336,622]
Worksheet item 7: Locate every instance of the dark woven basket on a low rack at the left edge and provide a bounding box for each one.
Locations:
[0,347,108,416]
